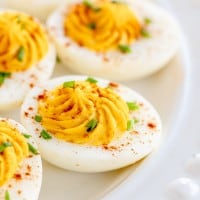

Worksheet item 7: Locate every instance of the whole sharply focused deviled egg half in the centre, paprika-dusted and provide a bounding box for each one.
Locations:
[21,76,161,172]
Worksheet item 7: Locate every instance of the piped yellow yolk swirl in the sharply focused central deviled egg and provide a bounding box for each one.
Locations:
[38,81,129,146]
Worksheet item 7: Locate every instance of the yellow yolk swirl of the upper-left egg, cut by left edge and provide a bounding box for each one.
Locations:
[0,12,48,73]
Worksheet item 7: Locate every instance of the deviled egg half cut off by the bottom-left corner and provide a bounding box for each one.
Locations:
[0,118,42,200]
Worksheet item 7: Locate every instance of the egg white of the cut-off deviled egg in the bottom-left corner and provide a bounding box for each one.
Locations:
[0,118,42,200]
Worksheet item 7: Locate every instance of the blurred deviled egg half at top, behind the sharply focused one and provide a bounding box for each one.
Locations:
[47,0,180,80]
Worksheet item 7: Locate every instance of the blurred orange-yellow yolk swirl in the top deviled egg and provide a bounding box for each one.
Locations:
[64,0,141,52]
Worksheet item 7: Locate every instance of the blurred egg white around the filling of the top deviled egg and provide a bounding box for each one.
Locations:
[47,0,180,80]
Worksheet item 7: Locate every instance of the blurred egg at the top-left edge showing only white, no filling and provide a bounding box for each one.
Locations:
[5,0,68,20]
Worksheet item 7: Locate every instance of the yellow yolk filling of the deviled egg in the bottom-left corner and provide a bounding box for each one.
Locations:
[0,121,29,187]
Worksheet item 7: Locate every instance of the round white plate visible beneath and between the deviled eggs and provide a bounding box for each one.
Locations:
[0,0,192,200]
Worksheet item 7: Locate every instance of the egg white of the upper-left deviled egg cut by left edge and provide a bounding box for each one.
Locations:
[0,9,56,111]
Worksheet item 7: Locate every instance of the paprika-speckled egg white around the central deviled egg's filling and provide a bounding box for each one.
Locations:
[21,76,161,172]
